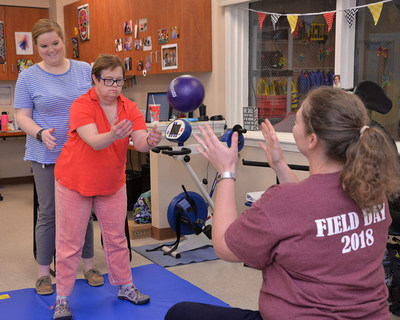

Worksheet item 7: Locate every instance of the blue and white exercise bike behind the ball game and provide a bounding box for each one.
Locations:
[146,119,247,259]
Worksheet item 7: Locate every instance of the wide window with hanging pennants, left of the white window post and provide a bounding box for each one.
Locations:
[248,0,336,132]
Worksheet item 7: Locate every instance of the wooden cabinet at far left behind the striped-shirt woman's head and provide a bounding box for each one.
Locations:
[0,6,49,80]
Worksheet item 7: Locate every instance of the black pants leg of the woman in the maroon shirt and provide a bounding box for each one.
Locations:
[164,302,262,320]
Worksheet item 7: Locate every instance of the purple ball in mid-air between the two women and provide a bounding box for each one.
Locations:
[167,75,204,112]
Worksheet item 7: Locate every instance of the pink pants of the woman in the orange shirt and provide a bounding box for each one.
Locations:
[55,181,132,296]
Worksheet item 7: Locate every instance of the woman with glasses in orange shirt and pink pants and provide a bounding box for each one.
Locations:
[53,55,161,319]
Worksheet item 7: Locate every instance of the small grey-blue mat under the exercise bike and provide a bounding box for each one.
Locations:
[132,244,219,268]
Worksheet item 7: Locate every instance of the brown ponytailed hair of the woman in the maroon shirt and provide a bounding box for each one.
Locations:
[302,87,400,209]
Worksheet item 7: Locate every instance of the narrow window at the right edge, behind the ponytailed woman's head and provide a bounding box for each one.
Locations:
[354,0,400,140]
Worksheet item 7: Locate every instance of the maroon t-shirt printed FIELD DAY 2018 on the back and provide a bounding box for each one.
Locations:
[225,173,391,320]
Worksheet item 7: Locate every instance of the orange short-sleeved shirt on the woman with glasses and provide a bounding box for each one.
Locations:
[54,88,147,196]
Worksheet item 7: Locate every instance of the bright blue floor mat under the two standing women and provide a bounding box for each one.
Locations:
[0,264,229,320]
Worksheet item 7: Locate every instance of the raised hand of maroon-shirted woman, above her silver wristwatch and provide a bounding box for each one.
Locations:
[193,124,238,172]
